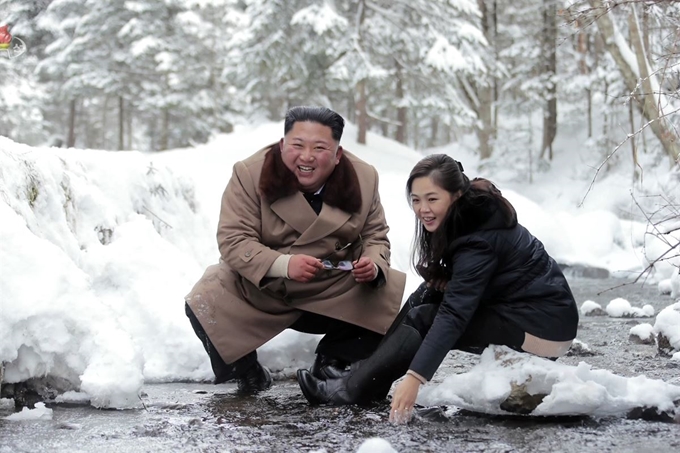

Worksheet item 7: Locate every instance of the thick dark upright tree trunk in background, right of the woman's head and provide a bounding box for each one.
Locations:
[540,0,557,160]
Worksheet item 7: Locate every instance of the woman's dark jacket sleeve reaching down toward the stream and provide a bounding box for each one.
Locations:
[410,238,498,380]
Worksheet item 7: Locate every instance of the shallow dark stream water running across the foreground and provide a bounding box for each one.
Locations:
[0,277,680,453]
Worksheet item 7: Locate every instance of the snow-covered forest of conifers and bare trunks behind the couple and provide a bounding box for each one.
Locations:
[0,0,680,240]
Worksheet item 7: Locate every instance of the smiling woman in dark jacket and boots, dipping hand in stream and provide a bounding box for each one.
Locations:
[298,154,578,422]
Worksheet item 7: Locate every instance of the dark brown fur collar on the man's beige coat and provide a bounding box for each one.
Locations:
[260,143,361,214]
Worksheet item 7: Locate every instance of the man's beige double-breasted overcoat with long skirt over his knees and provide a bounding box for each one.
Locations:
[186,144,406,363]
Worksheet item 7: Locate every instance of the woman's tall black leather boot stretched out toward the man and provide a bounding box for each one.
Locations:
[297,324,423,406]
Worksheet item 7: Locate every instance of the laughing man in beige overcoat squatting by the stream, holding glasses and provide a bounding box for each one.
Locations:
[186,107,406,392]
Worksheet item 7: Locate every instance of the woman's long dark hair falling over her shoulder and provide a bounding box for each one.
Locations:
[406,154,517,281]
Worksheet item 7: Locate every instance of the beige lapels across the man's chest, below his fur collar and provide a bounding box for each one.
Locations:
[271,192,352,245]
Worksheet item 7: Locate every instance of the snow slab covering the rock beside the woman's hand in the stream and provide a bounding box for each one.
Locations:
[417,346,680,416]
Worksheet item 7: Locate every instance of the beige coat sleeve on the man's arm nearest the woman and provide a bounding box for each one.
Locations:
[361,168,390,286]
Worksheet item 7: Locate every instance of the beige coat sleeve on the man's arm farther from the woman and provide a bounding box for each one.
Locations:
[217,162,281,287]
